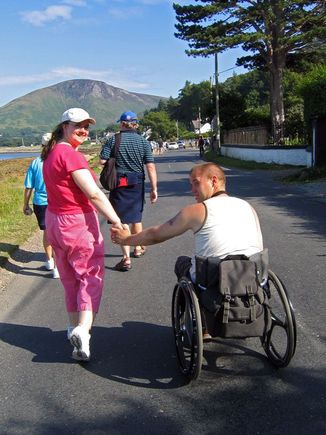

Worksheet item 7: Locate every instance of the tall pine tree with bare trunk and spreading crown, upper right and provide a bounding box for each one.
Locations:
[173,0,326,144]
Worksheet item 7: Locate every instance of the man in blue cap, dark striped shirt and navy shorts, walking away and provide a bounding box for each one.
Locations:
[100,112,157,272]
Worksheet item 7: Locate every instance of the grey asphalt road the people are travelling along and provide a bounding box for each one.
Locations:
[0,150,326,435]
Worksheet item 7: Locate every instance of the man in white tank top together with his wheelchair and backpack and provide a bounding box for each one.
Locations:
[111,163,296,377]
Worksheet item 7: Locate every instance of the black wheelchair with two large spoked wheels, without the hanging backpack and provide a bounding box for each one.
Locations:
[172,254,297,380]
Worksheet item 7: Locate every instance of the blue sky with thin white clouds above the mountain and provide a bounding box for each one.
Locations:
[0,0,244,107]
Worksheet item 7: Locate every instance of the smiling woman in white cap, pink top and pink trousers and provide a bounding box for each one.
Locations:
[41,108,121,361]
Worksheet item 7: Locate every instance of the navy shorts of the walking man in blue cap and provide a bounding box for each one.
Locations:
[110,175,144,224]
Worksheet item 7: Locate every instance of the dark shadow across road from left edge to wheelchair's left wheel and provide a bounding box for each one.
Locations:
[0,322,185,389]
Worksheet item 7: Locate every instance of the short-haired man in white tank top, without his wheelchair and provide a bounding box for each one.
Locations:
[111,163,263,282]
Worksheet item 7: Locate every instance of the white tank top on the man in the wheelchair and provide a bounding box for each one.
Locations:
[190,196,263,279]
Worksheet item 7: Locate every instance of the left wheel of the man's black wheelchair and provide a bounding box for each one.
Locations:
[172,278,203,380]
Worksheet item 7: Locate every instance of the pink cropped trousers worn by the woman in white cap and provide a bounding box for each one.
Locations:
[45,209,104,313]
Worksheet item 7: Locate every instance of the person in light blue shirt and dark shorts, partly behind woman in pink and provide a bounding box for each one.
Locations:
[23,133,60,278]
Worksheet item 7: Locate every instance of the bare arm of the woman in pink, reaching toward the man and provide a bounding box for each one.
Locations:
[71,169,121,226]
